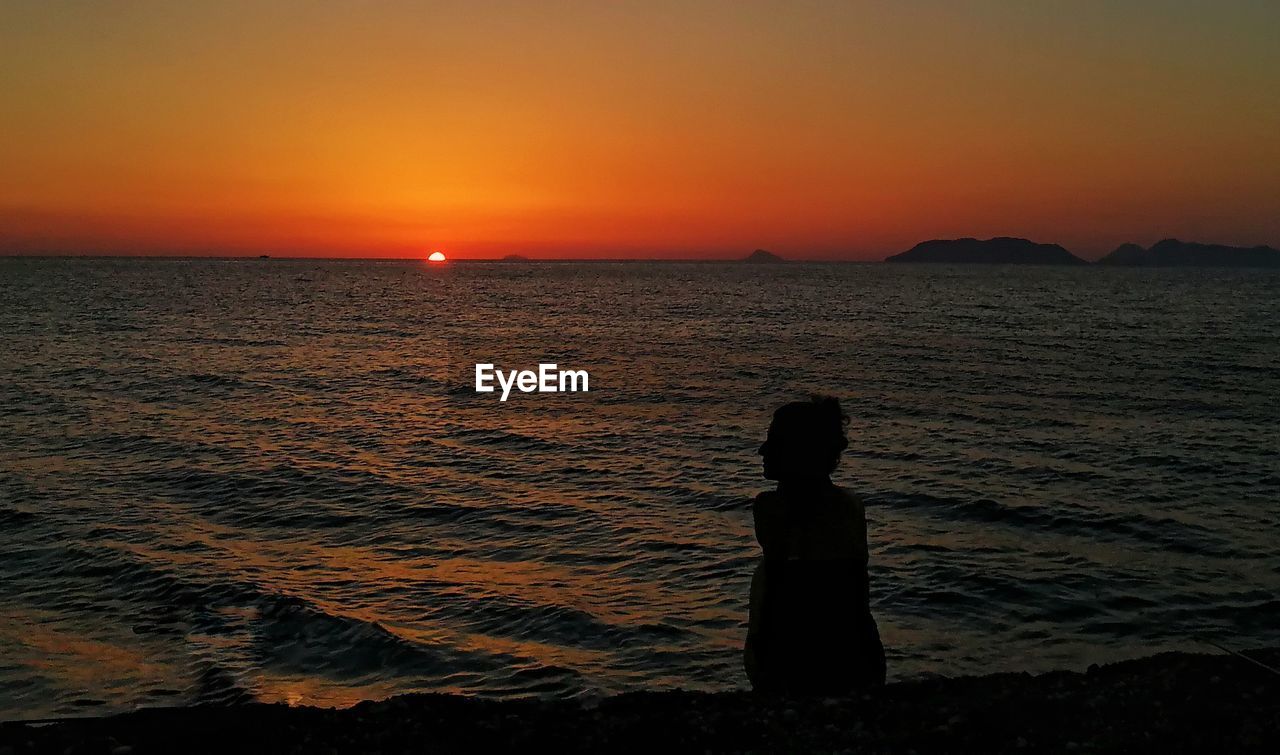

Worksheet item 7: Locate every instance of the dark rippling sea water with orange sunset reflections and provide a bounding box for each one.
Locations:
[0,258,1280,719]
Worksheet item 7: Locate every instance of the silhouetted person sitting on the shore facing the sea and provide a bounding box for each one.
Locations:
[744,398,884,695]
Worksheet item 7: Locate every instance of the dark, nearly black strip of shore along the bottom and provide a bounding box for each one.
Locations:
[0,648,1280,755]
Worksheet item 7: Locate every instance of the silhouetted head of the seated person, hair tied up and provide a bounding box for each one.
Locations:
[760,397,849,482]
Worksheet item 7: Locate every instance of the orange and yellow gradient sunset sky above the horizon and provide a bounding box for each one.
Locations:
[0,0,1280,258]
